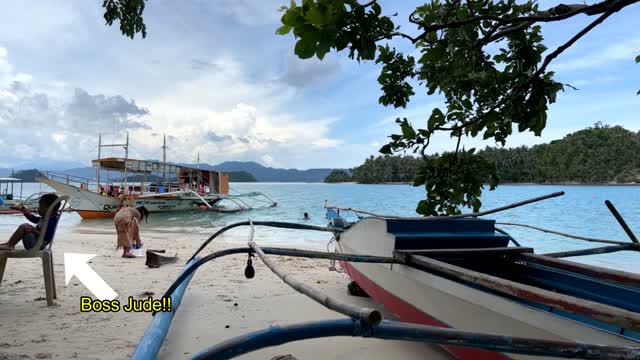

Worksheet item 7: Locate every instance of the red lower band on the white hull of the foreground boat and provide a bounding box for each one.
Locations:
[340,261,510,360]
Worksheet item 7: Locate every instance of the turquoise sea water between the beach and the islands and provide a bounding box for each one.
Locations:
[0,183,640,273]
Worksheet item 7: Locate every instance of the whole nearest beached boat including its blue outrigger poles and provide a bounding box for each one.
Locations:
[132,193,640,359]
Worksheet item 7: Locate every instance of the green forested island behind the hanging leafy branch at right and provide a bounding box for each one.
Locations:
[325,123,640,184]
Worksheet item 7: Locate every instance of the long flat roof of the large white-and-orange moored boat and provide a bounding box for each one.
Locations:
[91,157,222,175]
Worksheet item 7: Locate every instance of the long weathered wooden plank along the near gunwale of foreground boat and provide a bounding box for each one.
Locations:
[406,255,640,331]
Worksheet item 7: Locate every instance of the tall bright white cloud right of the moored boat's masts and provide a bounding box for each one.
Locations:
[138,56,342,164]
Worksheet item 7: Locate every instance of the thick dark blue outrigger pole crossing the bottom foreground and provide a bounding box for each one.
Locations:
[191,319,640,360]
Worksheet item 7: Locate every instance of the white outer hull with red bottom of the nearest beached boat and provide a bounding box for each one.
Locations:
[337,218,638,359]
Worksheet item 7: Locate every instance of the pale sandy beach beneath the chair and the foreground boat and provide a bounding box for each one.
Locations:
[0,224,448,359]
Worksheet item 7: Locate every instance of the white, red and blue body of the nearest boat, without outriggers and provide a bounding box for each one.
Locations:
[328,198,640,359]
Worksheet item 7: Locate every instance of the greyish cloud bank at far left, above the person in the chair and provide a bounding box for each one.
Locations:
[0,48,148,165]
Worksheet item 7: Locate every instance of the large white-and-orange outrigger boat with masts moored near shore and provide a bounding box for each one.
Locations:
[36,134,277,219]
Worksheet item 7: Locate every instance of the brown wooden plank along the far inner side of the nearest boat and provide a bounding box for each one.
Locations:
[521,254,640,288]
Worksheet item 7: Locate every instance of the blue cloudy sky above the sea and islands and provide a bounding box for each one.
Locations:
[0,0,640,169]
